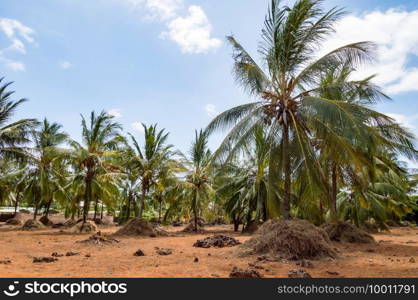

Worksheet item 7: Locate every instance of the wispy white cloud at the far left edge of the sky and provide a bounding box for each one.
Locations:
[0,18,35,71]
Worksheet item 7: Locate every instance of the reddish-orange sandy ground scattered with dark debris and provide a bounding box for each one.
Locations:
[0,220,418,278]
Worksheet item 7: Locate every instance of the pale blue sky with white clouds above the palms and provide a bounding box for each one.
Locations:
[0,0,418,164]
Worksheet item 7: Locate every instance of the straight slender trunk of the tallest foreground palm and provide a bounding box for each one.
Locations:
[282,124,291,220]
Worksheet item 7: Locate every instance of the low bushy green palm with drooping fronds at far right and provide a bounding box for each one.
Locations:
[337,153,418,228]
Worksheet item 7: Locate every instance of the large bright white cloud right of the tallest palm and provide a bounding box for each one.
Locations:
[323,9,418,94]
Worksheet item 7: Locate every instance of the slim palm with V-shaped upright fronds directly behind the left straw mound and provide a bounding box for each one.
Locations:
[128,124,174,218]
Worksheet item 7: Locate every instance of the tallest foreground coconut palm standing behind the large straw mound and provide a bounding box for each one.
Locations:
[208,0,398,219]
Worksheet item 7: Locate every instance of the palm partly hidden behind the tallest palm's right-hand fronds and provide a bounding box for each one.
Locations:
[313,64,418,221]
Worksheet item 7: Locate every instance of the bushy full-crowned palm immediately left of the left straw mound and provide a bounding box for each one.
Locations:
[71,111,124,230]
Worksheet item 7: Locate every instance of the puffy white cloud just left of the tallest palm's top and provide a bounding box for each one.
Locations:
[161,5,222,54]
